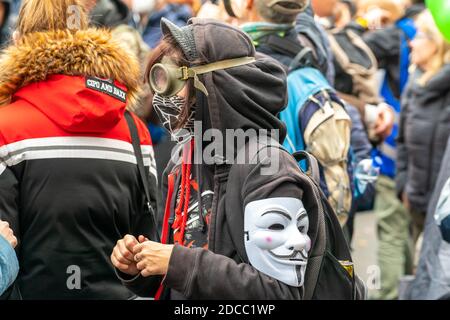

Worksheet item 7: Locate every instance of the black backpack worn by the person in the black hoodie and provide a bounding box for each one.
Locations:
[225,140,366,300]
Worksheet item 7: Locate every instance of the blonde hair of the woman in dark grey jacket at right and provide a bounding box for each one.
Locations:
[416,10,450,86]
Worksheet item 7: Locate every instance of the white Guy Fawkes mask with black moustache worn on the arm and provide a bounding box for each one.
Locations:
[244,198,311,287]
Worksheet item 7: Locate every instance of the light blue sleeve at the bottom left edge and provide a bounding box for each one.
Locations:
[0,236,19,296]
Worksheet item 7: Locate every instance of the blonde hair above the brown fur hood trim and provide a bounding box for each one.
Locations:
[16,0,88,36]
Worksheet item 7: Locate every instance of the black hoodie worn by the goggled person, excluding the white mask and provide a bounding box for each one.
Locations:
[118,19,322,300]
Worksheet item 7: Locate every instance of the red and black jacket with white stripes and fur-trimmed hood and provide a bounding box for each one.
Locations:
[0,29,156,299]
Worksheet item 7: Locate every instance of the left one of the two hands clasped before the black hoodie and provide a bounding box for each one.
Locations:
[111,235,140,276]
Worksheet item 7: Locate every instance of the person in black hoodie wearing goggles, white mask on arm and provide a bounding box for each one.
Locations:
[111,19,317,300]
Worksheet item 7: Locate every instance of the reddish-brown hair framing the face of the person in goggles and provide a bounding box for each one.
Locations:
[144,36,195,129]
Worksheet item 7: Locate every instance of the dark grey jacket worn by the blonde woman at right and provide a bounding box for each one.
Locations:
[396,65,450,212]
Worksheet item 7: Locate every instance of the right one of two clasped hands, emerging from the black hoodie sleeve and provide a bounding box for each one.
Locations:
[133,236,174,277]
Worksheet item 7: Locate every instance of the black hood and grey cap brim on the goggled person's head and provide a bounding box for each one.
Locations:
[161,18,287,140]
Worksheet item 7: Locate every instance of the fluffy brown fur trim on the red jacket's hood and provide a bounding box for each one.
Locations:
[0,29,141,110]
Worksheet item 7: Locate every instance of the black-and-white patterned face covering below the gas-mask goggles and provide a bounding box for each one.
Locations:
[153,94,195,143]
